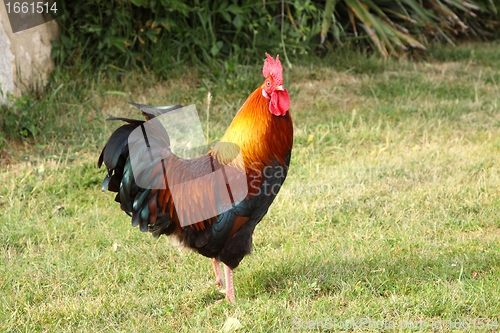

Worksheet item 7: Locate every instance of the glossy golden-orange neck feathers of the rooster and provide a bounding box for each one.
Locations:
[212,86,293,170]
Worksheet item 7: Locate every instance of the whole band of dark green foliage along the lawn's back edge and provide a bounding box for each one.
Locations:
[53,0,500,74]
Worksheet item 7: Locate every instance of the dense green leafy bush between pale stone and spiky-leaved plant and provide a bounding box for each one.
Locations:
[53,0,321,73]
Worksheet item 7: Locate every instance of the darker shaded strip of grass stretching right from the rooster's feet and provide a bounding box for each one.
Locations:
[238,249,500,317]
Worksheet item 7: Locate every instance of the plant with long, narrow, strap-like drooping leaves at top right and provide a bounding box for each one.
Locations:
[321,0,500,58]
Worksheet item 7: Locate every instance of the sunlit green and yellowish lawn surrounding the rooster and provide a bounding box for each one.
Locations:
[0,43,500,332]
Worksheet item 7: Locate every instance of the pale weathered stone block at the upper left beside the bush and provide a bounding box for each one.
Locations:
[0,1,59,104]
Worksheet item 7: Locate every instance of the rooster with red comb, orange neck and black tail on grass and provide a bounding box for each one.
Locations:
[98,53,293,304]
